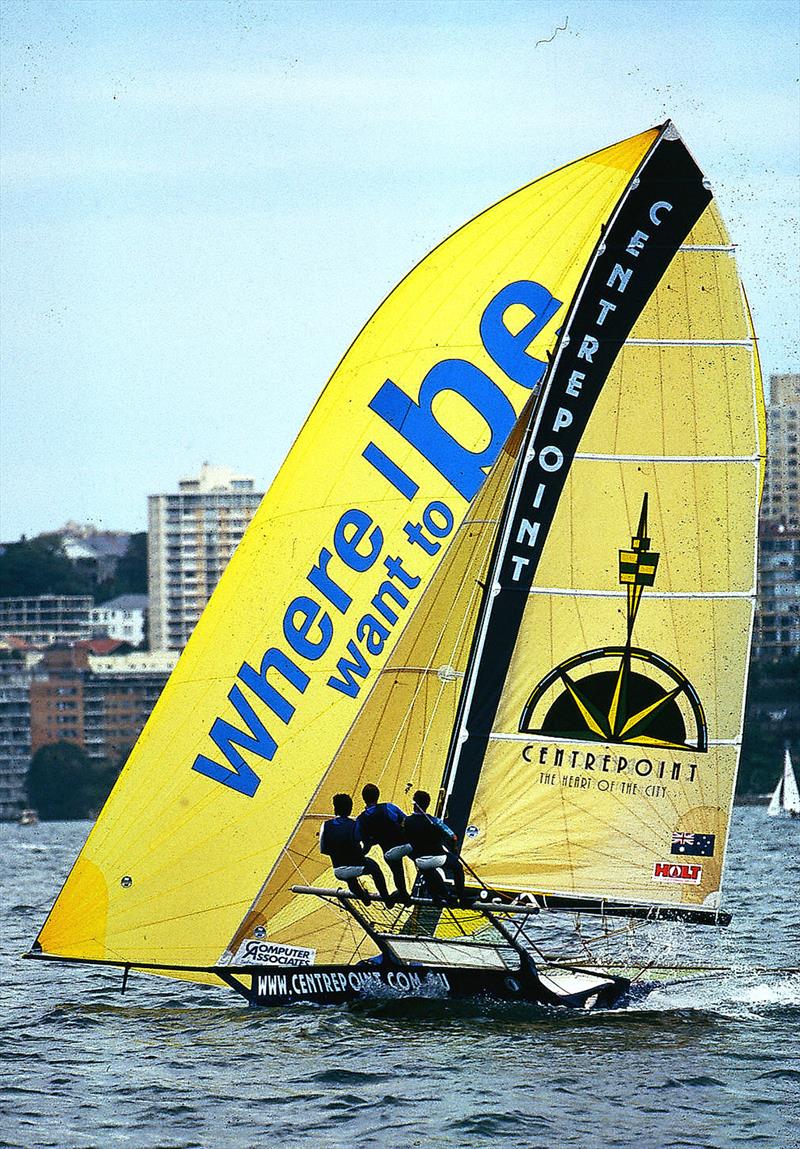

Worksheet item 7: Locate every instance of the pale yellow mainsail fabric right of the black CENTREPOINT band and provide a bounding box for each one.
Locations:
[466,205,763,907]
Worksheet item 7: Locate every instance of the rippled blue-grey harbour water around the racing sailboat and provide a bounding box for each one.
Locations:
[0,808,800,1149]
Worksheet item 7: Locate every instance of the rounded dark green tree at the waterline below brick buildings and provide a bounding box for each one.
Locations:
[28,742,118,822]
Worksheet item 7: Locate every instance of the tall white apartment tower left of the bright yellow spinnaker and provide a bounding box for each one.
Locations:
[147,463,263,650]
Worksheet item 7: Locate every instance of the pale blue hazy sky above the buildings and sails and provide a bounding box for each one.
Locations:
[0,0,800,540]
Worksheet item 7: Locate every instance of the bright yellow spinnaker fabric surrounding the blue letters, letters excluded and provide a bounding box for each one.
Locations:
[39,130,657,965]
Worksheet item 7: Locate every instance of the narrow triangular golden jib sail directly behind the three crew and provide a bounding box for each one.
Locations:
[230,418,521,962]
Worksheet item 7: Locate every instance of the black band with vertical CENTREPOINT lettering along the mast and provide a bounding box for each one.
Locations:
[443,121,711,836]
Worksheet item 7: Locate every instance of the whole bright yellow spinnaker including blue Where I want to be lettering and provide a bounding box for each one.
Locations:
[37,130,666,976]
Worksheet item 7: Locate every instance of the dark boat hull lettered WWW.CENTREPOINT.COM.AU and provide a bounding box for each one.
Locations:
[233,964,630,1010]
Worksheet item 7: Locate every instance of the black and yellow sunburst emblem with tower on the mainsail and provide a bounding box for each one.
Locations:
[520,494,708,750]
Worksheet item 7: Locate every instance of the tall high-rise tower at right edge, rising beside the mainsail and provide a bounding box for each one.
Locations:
[761,372,800,530]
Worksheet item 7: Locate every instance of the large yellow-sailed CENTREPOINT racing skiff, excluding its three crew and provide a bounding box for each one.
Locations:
[29,122,764,1009]
